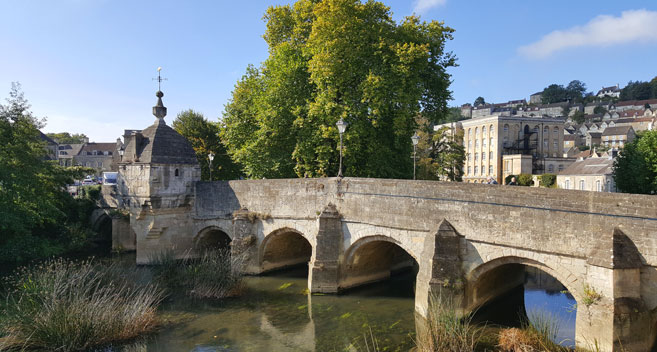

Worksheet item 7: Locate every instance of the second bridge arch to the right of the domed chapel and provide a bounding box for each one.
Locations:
[258,227,313,272]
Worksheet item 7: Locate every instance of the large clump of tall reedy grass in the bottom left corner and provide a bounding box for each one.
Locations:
[0,259,163,351]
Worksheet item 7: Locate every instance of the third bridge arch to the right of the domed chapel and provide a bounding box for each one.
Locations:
[339,235,419,289]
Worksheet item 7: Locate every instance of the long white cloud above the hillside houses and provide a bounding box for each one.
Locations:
[518,9,657,59]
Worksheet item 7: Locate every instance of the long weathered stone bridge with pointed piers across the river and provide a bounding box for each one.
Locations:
[115,179,657,351]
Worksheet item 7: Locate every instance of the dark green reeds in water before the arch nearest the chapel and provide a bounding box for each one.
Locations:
[151,249,244,299]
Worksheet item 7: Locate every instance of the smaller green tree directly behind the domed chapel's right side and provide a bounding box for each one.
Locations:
[172,109,240,180]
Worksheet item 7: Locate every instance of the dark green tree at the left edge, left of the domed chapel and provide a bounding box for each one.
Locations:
[0,83,102,262]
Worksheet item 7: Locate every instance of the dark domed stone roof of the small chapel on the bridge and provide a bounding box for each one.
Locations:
[121,119,198,164]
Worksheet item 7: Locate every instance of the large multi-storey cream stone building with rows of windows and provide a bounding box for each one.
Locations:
[461,116,570,183]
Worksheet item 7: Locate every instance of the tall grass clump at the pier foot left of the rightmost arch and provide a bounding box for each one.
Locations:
[416,296,484,352]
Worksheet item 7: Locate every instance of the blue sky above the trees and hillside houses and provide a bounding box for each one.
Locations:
[0,0,657,142]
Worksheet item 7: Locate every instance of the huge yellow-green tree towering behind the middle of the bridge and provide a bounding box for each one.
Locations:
[221,0,455,178]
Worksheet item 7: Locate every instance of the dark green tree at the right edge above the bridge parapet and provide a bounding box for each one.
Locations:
[613,131,657,194]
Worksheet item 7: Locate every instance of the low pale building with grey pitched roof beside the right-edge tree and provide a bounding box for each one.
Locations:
[557,156,616,192]
